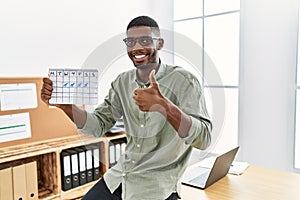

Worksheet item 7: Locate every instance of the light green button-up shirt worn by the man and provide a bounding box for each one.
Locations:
[81,61,211,200]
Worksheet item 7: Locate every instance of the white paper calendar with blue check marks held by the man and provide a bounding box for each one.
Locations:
[49,69,98,105]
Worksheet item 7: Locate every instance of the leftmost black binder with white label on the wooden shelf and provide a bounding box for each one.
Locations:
[60,150,72,191]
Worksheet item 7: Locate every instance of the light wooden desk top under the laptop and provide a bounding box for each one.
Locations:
[182,165,300,200]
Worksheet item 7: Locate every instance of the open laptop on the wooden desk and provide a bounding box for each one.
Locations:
[181,146,239,189]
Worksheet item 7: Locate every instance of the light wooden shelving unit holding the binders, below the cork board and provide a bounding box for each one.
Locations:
[0,132,125,200]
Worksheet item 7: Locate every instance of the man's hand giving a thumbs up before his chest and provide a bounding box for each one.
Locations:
[133,70,165,112]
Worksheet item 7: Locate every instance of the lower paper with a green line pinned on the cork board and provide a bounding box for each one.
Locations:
[0,112,31,143]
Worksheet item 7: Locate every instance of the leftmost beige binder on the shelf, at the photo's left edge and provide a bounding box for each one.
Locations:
[0,167,14,200]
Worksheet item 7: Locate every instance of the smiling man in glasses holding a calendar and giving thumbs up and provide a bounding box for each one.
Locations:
[41,16,211,200]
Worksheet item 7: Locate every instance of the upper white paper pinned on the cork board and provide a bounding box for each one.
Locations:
[0,83,37,111]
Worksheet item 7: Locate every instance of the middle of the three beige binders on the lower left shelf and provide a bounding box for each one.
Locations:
[13,164,27,199]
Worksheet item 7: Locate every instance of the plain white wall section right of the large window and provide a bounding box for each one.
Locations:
[239,0,299,171]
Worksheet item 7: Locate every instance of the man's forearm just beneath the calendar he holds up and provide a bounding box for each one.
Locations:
[57,104,87,128]
